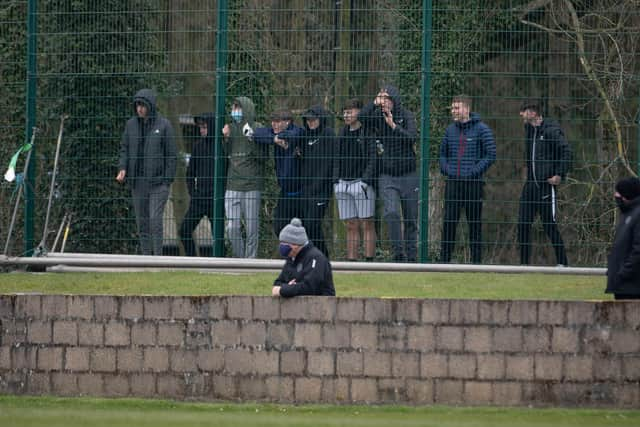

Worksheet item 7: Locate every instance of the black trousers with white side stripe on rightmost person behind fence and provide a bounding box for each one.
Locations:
[518,181,568,265]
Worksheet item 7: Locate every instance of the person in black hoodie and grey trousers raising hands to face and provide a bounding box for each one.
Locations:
[358,85,420,262]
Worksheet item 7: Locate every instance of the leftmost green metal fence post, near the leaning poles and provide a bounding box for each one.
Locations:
[23,0,38,256]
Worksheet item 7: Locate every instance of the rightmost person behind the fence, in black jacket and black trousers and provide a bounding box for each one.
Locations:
[518,100,572,266]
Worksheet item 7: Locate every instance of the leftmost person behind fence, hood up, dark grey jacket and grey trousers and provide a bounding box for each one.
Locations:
[116,89,177,255]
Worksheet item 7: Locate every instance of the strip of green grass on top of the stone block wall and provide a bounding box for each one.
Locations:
[0,272,611,300]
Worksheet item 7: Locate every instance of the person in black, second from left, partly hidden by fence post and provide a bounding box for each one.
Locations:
[180,113,225,256]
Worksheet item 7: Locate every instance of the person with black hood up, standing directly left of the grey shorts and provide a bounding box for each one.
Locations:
[299,105,335,257]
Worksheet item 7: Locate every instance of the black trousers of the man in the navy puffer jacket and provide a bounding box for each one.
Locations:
[440,179,484,264]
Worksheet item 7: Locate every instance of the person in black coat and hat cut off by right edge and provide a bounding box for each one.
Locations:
[605,178,640,299]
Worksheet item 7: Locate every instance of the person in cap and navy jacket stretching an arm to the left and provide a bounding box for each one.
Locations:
[253,110,304,236]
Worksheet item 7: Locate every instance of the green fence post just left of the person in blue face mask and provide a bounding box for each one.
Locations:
[212,0,229,257]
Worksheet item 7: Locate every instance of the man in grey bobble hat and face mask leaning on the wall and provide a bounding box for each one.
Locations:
[271,218,336,297]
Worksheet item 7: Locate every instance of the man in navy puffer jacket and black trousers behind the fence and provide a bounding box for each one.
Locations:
[440,95,496,264]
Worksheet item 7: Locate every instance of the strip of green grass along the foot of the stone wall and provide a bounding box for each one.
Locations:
[0,396,640,427]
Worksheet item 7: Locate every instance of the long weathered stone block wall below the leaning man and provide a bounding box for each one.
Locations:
[0,295,640,408]
